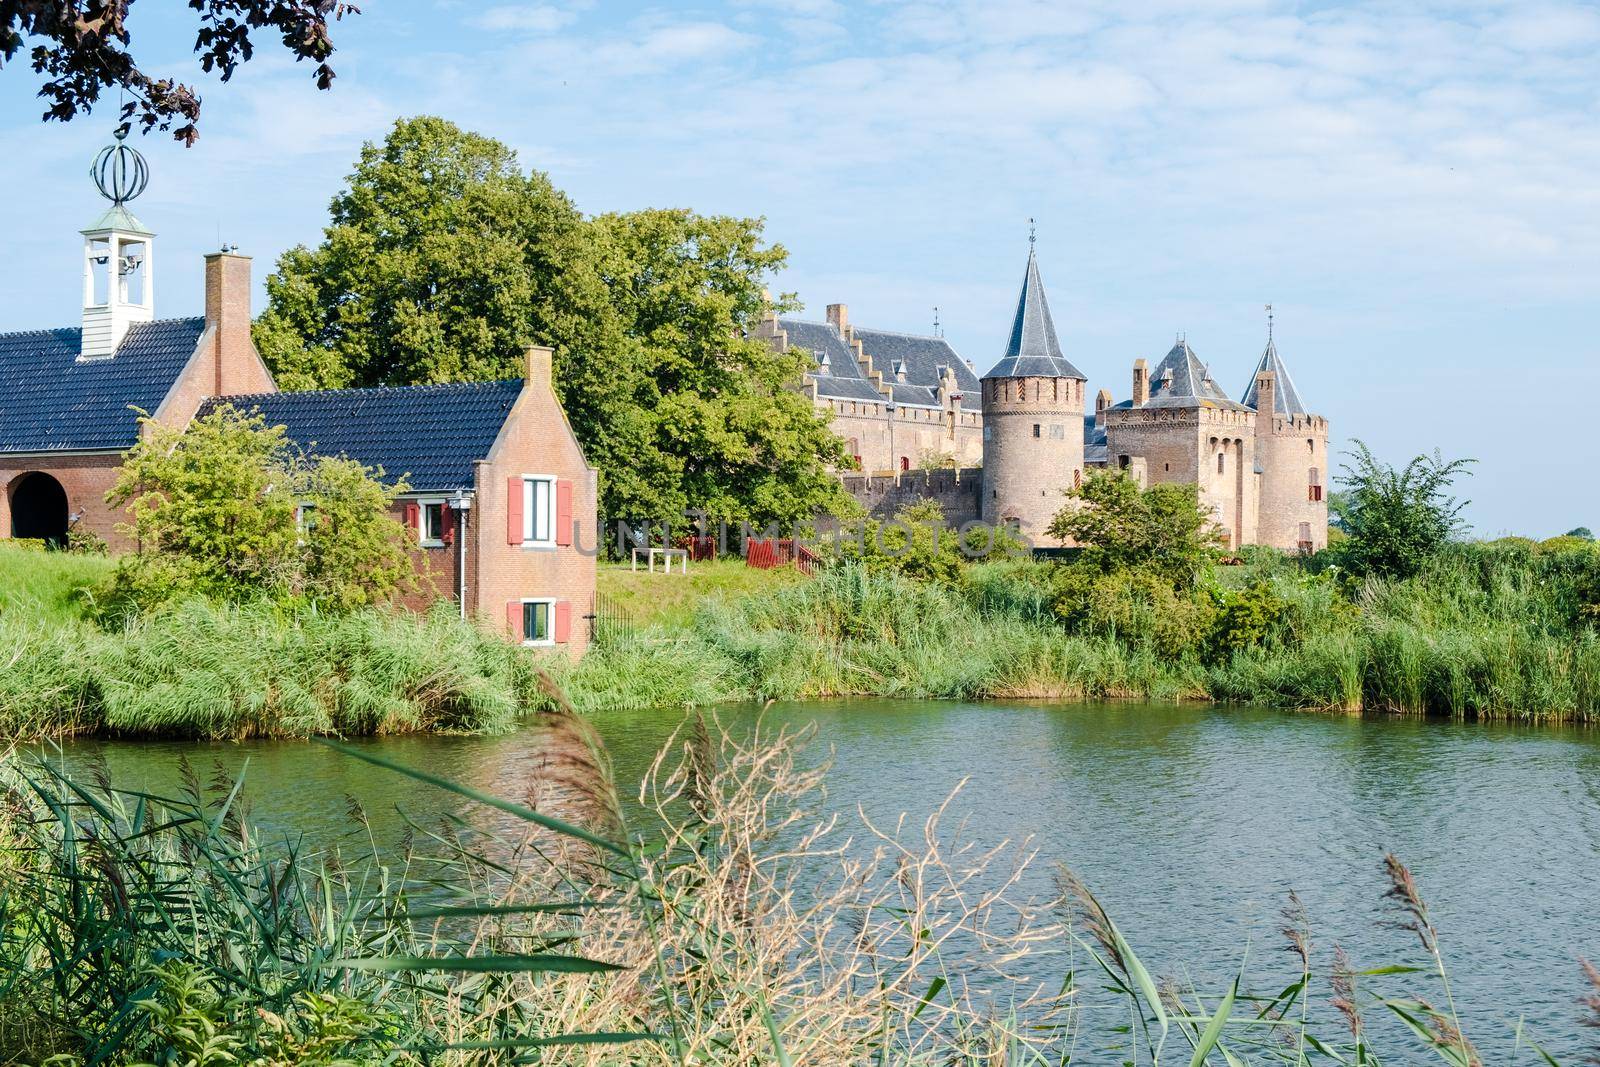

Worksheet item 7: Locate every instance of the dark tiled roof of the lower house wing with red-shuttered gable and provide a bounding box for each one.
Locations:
[200,379,522,493]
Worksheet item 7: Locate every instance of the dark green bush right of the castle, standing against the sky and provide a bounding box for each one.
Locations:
[1338,442,1475,577]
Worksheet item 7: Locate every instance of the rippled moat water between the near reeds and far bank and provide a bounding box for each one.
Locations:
[37,701,1600,1062]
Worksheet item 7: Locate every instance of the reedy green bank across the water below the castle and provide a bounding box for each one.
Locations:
[566,544,1600,721]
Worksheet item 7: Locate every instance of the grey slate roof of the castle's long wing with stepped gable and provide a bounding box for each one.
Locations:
[778,318,981,411]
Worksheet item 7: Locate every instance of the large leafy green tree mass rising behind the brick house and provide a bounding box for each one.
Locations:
[256,117,848,523]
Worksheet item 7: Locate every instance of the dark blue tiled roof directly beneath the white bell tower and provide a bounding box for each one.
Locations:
[0,318,205,453]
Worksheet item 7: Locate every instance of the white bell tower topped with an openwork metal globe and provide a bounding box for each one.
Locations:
[78,130,155,360]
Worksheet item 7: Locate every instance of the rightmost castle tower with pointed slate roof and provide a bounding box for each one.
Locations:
[1245,331,1328,552]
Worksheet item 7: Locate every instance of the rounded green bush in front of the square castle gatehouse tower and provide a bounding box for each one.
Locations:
[1048,470,1222,589]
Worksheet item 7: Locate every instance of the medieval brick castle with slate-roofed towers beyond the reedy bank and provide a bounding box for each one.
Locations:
[755,245,1328,552]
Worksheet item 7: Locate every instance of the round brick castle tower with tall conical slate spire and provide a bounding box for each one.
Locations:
[982,245,1086,544]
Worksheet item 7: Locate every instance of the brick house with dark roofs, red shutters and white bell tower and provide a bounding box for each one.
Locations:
[0,133,598,654]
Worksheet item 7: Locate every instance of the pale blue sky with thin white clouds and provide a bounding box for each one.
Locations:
[0,0,1600,536]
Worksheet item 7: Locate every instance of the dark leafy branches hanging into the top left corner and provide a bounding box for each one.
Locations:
[0,0,357,144]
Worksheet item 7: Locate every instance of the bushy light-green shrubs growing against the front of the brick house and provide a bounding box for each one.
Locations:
[106,406,413,611]
